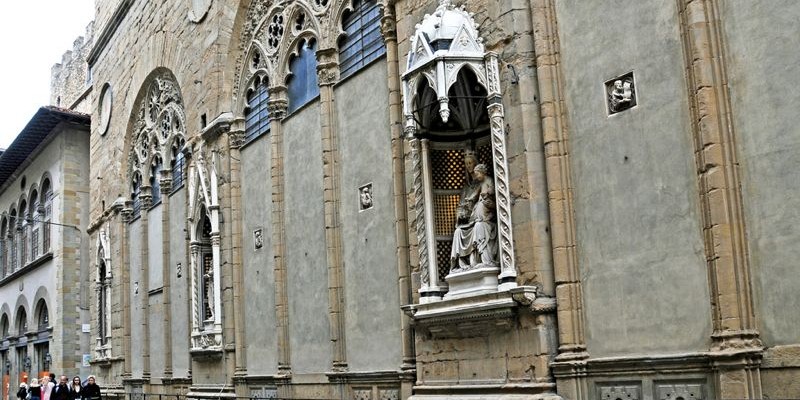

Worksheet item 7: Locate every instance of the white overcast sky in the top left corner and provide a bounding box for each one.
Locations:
[0,0,94,148]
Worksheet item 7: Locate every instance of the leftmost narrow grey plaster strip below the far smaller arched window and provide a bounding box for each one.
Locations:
[130,218,147,377]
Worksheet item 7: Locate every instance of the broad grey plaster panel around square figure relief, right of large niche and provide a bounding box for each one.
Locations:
[556,0,711,357]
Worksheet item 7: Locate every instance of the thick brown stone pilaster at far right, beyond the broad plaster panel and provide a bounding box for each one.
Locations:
[678,0,763,398]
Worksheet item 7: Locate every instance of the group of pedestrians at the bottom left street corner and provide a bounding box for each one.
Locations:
[17,374,102,400]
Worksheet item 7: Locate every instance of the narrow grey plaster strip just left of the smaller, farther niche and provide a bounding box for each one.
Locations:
[167,186,191,377]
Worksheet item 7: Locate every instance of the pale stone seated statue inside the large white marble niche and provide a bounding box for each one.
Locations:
[450,153,497,272]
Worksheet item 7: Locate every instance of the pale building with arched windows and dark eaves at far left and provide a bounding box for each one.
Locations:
[0,106,90,399]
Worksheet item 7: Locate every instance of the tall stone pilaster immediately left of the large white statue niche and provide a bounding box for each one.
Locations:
[381,1,416,384]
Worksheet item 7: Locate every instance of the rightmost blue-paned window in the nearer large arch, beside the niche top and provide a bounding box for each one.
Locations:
[339,0,386,78]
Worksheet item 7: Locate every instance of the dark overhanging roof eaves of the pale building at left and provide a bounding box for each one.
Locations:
[0,106,91,193]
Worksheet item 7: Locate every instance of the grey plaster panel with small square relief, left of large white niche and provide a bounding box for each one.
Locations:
[335,61,402,371]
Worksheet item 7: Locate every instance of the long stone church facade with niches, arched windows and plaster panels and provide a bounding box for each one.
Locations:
[86,0,800,400]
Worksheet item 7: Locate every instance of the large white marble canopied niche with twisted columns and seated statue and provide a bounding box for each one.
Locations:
[402,0,517,303]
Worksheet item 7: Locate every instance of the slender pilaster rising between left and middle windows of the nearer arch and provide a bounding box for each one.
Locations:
[267,86,292,375]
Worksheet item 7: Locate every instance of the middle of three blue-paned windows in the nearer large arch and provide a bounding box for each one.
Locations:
[286,39,319,113]
